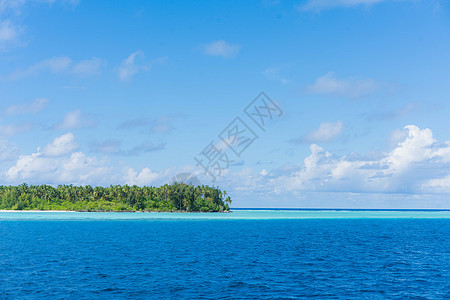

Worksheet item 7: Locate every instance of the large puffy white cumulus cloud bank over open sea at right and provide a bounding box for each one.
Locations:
[273,125,450,193]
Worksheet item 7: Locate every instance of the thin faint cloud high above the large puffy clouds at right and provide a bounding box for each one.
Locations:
[306,72,379,98]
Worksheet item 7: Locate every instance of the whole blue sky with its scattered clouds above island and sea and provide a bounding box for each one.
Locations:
[0,0,450,208]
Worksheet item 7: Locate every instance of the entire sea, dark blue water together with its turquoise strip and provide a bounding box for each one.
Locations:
[0,211,450,299]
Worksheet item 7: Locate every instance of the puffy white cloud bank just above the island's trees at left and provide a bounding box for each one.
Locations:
[0,132,169,185]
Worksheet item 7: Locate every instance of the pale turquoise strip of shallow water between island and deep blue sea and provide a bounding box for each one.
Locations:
[0,210,450,221]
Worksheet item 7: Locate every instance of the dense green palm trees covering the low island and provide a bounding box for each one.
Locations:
[0,183,231,212]
